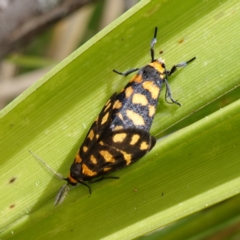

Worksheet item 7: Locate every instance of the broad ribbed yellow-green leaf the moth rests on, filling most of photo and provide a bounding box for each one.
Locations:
[0,0,240,239]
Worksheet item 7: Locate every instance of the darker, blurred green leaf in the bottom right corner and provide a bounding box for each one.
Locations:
[137,194,240,240]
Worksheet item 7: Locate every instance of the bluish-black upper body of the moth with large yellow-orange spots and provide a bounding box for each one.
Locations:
[110,63,164,131]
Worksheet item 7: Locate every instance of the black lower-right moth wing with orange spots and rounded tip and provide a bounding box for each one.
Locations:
[80,128,156,178]
